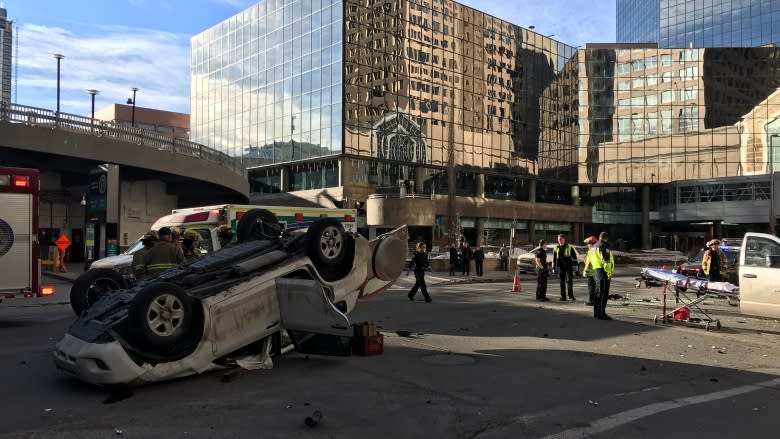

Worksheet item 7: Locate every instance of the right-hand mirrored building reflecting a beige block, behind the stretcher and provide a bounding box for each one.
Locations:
[540,44,780,250]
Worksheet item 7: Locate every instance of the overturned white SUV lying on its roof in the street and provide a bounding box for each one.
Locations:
[54,209,407,385]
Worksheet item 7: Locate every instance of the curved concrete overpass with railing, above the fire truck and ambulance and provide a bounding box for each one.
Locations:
[0,104,249,260]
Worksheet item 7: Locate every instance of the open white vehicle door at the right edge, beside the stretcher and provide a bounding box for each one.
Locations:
[739,234,780,318]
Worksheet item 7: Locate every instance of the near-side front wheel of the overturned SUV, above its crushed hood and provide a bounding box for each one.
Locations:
[127,282,193,350]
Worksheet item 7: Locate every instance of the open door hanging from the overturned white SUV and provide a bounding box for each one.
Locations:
[276,278,352,355]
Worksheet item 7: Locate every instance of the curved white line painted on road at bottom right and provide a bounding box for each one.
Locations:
[544,378,780,439]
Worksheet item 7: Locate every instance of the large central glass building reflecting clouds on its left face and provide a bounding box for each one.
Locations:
[191,0,589,248]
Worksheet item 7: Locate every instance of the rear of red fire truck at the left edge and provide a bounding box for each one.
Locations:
[0,166,54,301]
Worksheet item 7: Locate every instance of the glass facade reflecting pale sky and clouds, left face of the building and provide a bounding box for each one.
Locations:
[190,0,344,166]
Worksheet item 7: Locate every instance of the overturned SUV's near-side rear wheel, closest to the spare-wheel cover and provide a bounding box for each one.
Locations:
[306,218,355,281]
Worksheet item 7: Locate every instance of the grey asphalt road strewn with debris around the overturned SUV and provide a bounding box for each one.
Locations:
[0,277,780,439]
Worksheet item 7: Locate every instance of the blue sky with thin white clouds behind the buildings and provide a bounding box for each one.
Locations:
[0,0,615,115]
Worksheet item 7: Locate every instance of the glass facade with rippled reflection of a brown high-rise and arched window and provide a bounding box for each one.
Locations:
[344,0,574,192]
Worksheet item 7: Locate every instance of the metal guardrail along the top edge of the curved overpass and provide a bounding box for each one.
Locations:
[0,102,246,175]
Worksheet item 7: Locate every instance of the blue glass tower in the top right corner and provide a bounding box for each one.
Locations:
[616,0,780,48]
